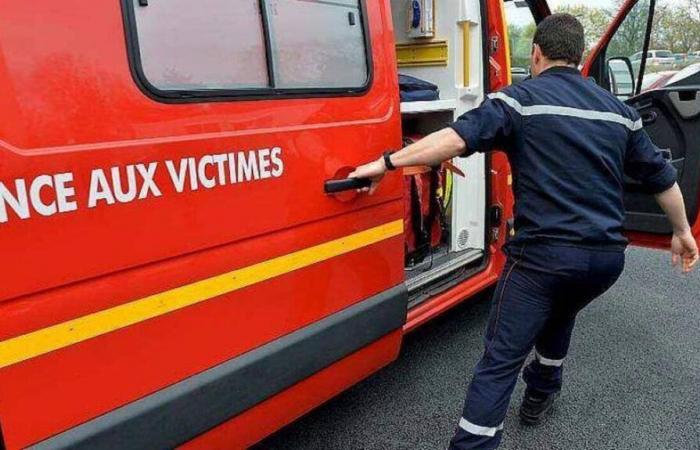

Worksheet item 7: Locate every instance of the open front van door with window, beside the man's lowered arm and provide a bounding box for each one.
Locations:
[583,0,700,248]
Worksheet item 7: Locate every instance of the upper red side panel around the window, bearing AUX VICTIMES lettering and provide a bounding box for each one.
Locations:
[0,0,401,300]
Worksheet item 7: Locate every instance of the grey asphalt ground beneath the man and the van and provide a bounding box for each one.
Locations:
[256,248,700,450]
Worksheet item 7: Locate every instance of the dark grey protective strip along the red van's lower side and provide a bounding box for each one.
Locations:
[30,284,408,450]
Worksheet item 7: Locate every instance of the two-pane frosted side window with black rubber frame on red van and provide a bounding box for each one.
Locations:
[123,0,370,100]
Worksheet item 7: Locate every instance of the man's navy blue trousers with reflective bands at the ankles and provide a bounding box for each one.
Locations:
[450,244,625,450]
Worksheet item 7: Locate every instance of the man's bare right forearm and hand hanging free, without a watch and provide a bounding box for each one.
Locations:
[656,183,698,272]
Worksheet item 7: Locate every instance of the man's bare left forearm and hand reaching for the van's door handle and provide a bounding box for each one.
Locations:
[349,128,467,193]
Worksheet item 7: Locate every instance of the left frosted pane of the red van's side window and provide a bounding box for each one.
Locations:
[132,0,269,91]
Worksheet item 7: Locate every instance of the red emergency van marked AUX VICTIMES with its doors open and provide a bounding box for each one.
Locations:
[0,0,700,449]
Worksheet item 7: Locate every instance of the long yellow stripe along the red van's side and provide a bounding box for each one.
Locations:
[0,220,403,368]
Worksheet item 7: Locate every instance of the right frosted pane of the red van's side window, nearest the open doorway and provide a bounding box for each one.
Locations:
[270,0,367,88]
